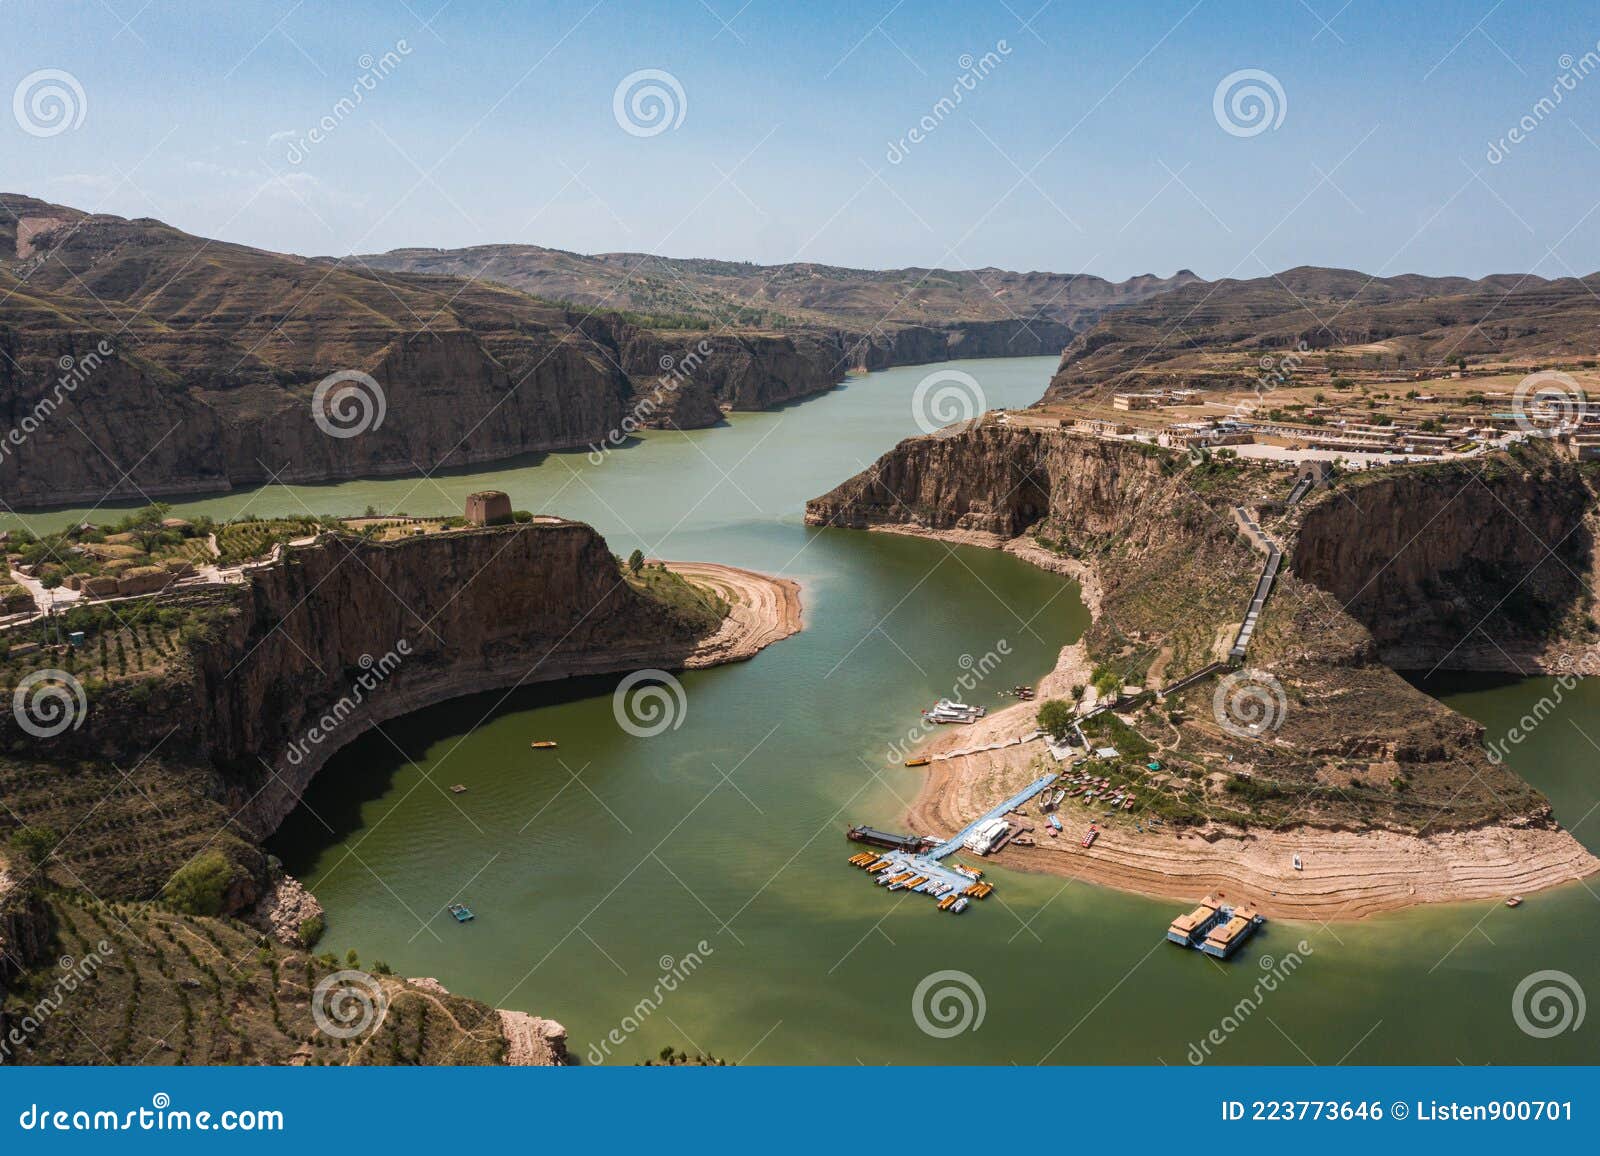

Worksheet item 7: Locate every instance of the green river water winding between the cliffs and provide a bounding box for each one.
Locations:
[6,359,1600,1065]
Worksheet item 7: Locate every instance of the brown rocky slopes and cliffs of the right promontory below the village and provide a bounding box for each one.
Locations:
[806,421,1568,833]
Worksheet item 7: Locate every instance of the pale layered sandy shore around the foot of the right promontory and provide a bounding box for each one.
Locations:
[907,550,1600,921]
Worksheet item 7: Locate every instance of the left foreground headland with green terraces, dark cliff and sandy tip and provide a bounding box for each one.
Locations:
[0,517,798,1065]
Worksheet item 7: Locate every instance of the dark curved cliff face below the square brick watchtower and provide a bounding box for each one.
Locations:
[184,522,717,837]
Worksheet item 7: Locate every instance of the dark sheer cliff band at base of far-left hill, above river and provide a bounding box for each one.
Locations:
[0,327,632,506]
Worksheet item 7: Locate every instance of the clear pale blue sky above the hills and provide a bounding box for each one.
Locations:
[0,0,1600,277]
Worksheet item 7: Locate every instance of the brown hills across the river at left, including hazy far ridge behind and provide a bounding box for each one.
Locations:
[0,194,1203,508]
